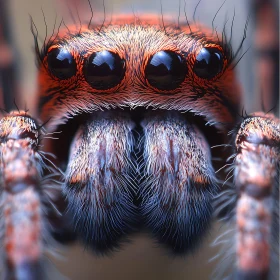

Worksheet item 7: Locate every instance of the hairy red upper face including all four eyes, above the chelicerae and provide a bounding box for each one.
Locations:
[39,19,240,128]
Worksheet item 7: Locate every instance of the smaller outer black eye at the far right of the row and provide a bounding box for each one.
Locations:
[193,48,224,79]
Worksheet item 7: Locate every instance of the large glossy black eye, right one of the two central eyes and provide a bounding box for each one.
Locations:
[145,51,187,90]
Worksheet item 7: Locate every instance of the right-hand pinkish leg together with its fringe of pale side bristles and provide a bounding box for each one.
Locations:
[215,112,280,279]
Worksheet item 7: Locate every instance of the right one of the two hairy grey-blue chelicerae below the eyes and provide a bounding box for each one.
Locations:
[140,112,217,254]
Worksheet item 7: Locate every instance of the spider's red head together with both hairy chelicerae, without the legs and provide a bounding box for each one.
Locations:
[36,19,243,253]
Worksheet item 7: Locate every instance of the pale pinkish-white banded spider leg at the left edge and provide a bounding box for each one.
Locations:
[0,111,58,280]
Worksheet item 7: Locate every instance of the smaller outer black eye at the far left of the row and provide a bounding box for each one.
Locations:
[48,48,77,80]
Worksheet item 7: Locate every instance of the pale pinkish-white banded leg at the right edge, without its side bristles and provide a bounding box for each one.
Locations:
[235,113,280,279]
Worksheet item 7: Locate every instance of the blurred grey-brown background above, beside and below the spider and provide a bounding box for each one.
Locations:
[0,0,279,280]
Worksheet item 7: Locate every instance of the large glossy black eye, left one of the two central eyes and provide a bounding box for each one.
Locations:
[84,51,125,90]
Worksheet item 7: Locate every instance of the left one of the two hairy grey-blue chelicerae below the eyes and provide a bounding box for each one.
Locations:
[64,111,138,253]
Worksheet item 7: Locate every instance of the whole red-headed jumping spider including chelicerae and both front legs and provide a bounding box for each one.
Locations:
[0,0,280,279]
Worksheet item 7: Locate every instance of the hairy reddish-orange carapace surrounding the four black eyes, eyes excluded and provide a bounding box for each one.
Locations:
[38,17,240,128]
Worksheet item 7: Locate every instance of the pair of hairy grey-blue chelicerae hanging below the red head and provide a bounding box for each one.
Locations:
[60,110,217,254]
